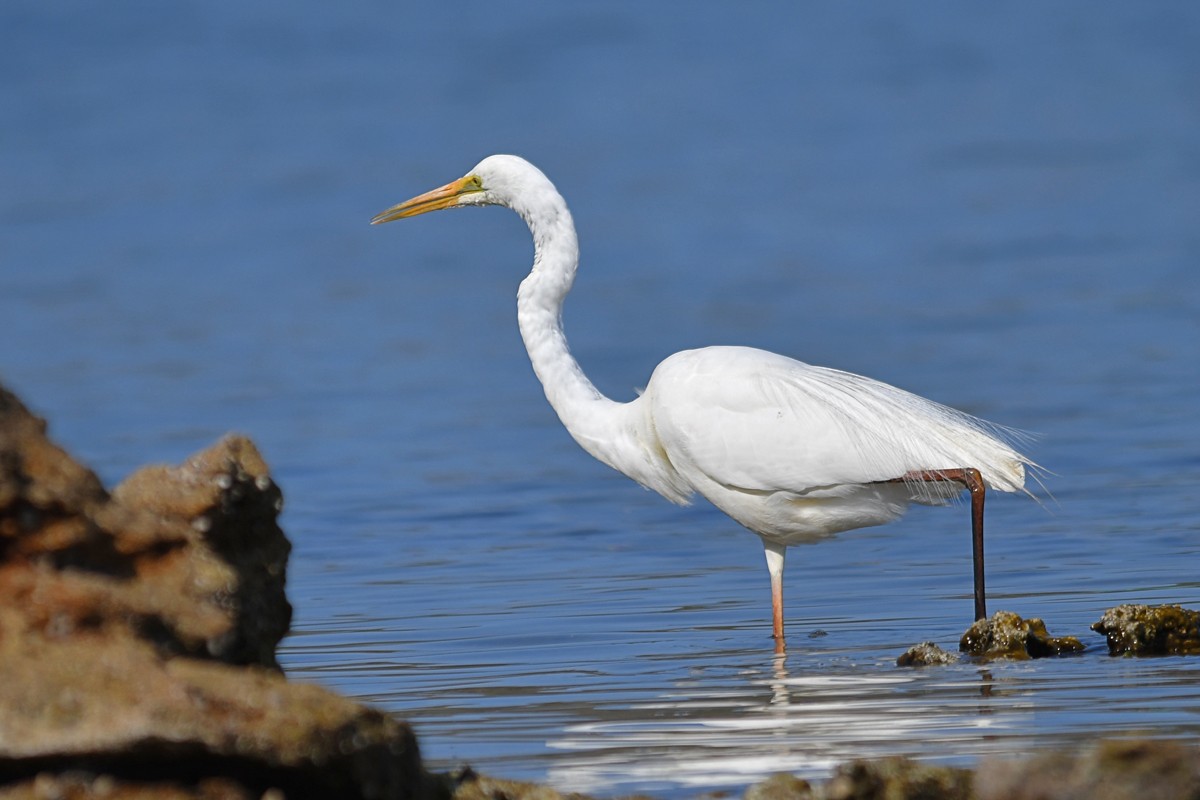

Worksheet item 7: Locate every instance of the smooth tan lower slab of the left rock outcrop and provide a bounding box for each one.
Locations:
[0,633,424,798]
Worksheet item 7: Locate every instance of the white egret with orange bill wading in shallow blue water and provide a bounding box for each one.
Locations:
[371,155,1036,652]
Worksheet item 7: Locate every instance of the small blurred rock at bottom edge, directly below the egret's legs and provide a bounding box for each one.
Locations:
[817,758,973,800]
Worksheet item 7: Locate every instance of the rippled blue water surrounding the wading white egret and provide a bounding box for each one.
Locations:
[0,0,1200,794]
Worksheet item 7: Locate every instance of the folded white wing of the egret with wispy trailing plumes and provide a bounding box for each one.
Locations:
[643,348,1031,493]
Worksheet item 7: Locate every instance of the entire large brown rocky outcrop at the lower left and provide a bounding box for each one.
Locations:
[0,389,430,799]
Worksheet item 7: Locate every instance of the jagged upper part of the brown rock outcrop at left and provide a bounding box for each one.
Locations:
[0,389,292,667]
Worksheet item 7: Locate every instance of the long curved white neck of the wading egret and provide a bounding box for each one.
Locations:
[514,192,622,464]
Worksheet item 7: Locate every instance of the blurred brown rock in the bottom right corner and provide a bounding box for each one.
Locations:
[974,740,1200,800]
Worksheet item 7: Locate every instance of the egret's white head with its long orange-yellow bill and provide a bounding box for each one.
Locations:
[371,156,553,224]
